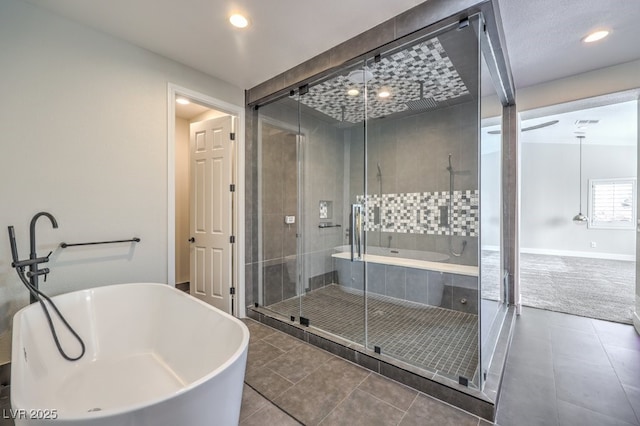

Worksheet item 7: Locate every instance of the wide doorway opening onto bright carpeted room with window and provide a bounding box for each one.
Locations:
[519,94,638,324]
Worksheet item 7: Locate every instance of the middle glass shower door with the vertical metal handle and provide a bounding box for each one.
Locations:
[299,62,368,345]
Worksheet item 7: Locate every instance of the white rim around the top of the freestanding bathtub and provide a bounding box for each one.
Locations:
[11,282,250,421]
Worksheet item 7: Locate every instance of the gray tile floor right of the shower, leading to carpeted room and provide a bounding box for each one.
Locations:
[497,307,640,426]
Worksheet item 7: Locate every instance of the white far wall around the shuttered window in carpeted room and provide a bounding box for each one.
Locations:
[520,143,636,257]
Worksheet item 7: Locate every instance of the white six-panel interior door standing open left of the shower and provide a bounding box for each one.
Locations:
[189,116,234,313]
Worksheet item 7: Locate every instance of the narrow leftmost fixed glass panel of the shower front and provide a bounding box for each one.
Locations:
[257,95,305,318]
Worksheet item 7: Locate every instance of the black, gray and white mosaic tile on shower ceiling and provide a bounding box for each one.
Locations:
[300,37,469,124]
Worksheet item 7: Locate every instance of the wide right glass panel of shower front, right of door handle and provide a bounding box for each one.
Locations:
[365,19,479,386]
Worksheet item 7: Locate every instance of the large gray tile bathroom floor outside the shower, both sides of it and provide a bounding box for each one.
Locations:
[241,307,640,426]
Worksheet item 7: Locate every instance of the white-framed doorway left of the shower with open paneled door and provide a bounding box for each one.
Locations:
[168,84,244,316]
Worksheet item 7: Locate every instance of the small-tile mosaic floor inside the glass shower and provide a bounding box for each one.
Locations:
[266,284,478,380]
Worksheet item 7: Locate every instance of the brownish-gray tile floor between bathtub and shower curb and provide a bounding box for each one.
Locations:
[240,319,490,426]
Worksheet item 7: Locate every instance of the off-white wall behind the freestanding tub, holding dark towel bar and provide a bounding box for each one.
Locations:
[0,0,244,363]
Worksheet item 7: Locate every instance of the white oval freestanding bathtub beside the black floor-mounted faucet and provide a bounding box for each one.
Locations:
[11,283,249,426]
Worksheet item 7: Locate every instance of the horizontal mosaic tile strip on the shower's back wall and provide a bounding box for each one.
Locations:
[356,190,479,237]
